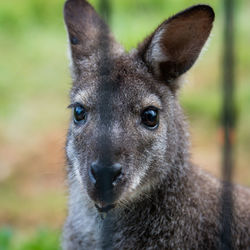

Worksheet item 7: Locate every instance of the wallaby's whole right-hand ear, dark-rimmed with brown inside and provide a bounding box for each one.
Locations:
[138,5,214,89]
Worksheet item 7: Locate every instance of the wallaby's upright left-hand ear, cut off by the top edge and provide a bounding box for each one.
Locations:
[64,0,114,66]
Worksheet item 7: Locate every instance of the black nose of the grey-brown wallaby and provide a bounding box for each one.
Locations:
[89,162,122,189]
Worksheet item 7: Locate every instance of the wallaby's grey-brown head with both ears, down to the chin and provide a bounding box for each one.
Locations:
[64,0,214,213]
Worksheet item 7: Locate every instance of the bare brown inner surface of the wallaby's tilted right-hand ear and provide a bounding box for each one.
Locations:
[160,8,213,62]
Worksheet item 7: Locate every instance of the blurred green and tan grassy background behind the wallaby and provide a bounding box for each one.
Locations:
[0,0,250,250]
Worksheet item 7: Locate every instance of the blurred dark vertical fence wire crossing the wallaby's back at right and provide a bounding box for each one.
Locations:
[219,0,235,250]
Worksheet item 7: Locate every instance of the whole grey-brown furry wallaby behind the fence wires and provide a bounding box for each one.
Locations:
[62,0,250,250]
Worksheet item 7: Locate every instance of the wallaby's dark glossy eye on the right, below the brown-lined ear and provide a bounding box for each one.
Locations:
[141,107,159,129]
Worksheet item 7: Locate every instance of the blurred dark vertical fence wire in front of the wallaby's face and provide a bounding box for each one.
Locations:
[98,0,114,250]
